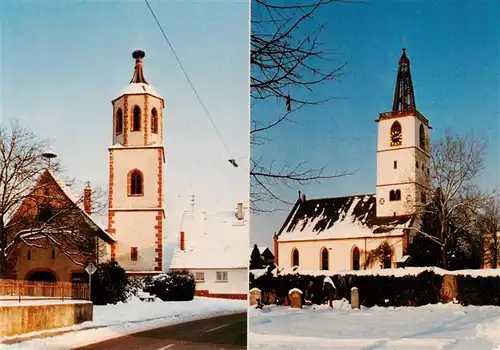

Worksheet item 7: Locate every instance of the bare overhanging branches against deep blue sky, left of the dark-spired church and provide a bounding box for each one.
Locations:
[250,0,353,211]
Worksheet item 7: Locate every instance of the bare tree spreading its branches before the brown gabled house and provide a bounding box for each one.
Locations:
[0,123,106,277]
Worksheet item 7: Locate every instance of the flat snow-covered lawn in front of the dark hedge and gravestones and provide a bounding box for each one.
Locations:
[249,301,500,350]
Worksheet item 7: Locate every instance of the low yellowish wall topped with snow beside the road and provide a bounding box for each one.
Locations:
[0,300,93,337]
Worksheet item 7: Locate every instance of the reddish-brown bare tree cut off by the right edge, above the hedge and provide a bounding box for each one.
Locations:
[477,193,500,269]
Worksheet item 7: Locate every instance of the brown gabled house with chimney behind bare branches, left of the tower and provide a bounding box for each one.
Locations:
[6,168,115,282]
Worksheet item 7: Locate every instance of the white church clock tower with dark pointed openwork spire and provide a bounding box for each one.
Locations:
[376,49,431,217]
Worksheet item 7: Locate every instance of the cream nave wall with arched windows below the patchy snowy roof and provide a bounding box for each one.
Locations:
[278,237,403,271]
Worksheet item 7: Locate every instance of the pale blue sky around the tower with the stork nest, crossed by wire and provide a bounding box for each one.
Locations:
[0,0,249,270]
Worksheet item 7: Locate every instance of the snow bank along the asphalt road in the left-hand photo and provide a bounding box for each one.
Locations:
[0,298,248,350]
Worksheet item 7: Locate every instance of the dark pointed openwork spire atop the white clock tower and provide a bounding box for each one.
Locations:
[392,48,416,112]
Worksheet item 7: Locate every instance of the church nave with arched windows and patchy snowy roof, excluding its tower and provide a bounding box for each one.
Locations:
[274,195,415,271]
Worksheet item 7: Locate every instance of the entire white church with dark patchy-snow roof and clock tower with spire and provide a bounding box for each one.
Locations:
[274,49,431,271]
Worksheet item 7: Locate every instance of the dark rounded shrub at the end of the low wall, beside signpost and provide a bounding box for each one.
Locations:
[91,260,129,305]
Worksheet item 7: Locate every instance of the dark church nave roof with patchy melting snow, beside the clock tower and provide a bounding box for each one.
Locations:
[278,194,414,241]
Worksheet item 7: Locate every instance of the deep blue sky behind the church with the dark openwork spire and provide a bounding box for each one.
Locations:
[251,0,500,248]
